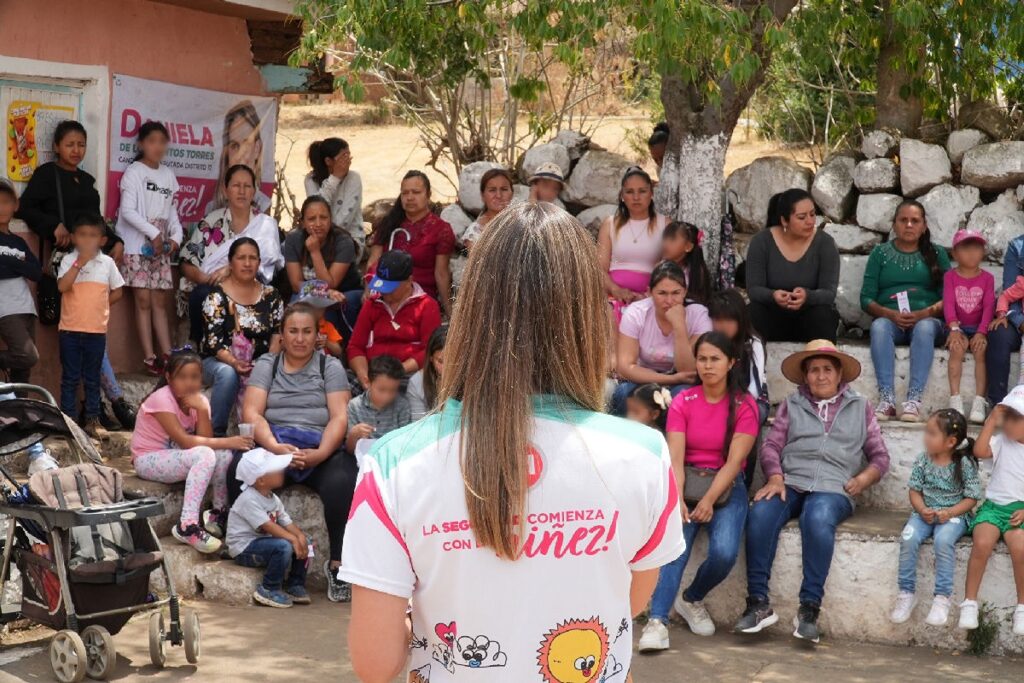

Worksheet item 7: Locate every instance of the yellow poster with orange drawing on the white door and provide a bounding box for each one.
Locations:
[7,99,75,182]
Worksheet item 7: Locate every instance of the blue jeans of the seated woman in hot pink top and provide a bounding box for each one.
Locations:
[650,475,748,624]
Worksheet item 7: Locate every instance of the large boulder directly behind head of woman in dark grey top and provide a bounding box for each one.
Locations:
[725,157,813,232]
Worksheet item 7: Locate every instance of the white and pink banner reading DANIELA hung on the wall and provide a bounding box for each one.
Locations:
[106,75,278,223]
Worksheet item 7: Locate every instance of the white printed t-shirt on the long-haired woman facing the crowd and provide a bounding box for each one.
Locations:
[340,396,685,683]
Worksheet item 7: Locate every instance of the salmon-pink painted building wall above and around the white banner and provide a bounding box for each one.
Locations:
[0,0,264,401]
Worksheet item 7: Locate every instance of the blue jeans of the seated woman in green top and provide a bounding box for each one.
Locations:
[871,317,946,403]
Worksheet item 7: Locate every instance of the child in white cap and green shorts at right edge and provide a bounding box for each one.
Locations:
[959,385,1024,636]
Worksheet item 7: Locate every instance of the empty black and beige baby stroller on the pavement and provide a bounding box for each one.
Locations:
[0,384,200,683]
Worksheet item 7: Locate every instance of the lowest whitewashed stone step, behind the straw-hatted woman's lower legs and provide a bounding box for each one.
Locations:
[683,510,1024,653]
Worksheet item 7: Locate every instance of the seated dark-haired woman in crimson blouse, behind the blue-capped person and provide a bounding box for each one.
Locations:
[367,171,455,313]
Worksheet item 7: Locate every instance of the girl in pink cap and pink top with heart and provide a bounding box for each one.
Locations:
[942,230,995,424]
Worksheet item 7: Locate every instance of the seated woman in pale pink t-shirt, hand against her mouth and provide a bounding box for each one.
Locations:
[611,261,711,416]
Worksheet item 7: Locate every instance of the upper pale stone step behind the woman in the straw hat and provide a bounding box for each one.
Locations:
[767,343,1020,413]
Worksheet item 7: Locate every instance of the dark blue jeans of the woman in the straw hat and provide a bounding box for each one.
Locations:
[746,486,853,605]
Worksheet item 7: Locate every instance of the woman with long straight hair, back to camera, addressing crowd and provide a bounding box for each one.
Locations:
[340,203,683,682]
